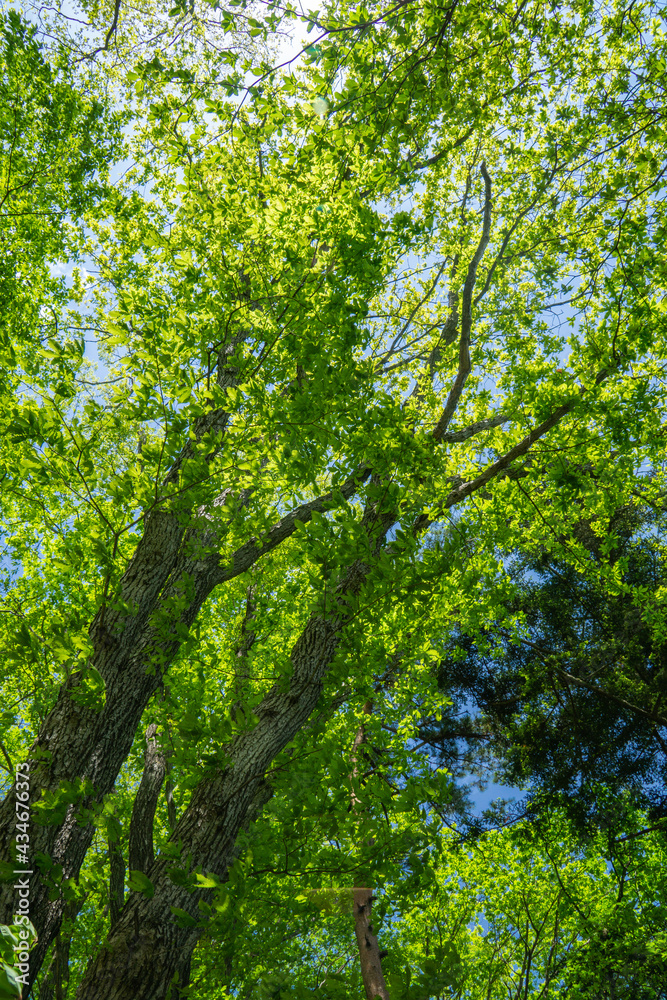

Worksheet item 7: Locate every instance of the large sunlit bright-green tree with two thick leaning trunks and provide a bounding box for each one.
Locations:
[0,3,665,1000]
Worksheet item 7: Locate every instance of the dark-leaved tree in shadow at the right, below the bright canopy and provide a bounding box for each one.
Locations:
[423,508,667,835]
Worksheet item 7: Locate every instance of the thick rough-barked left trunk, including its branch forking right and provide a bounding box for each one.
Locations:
[0,370,367,986]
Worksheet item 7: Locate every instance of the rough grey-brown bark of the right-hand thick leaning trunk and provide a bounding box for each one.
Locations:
[77,508,396,1000]
